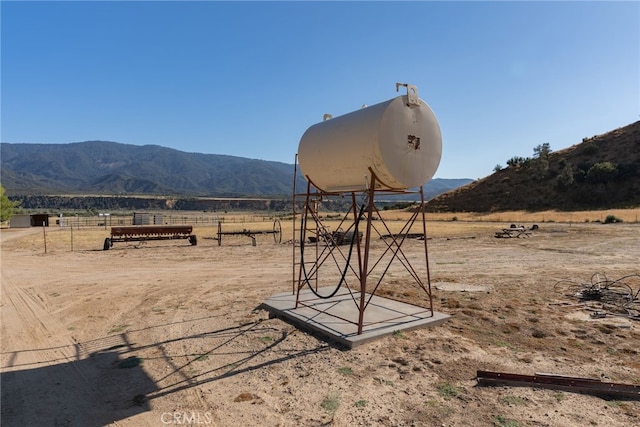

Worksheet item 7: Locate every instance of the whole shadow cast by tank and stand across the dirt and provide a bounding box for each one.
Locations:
[0,316,331,427]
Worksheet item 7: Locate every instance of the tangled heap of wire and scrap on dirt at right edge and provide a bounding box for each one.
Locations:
[554,273,640,320]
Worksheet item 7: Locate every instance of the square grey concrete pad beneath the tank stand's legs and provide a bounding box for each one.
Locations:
[260,288,451,349]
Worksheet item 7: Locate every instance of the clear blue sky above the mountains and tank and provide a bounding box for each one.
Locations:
[0,1,640,179]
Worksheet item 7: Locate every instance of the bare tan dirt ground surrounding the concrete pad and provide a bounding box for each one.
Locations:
[0,221,640,427]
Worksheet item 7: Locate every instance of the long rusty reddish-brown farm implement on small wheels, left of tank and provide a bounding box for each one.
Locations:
[103,225,198,251]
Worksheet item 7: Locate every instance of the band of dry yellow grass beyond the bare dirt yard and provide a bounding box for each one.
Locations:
[7,209,640,251]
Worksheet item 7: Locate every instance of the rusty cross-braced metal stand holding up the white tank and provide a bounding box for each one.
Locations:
[292,171,434,335]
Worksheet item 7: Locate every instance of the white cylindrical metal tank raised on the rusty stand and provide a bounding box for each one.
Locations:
[298,95,442,192]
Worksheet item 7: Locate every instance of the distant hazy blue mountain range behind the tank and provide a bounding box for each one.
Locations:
[0,141,471,198]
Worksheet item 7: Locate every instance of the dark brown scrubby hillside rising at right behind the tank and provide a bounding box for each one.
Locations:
[427,121,640,212]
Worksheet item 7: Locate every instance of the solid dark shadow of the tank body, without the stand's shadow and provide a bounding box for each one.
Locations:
[0,351,156,427]
